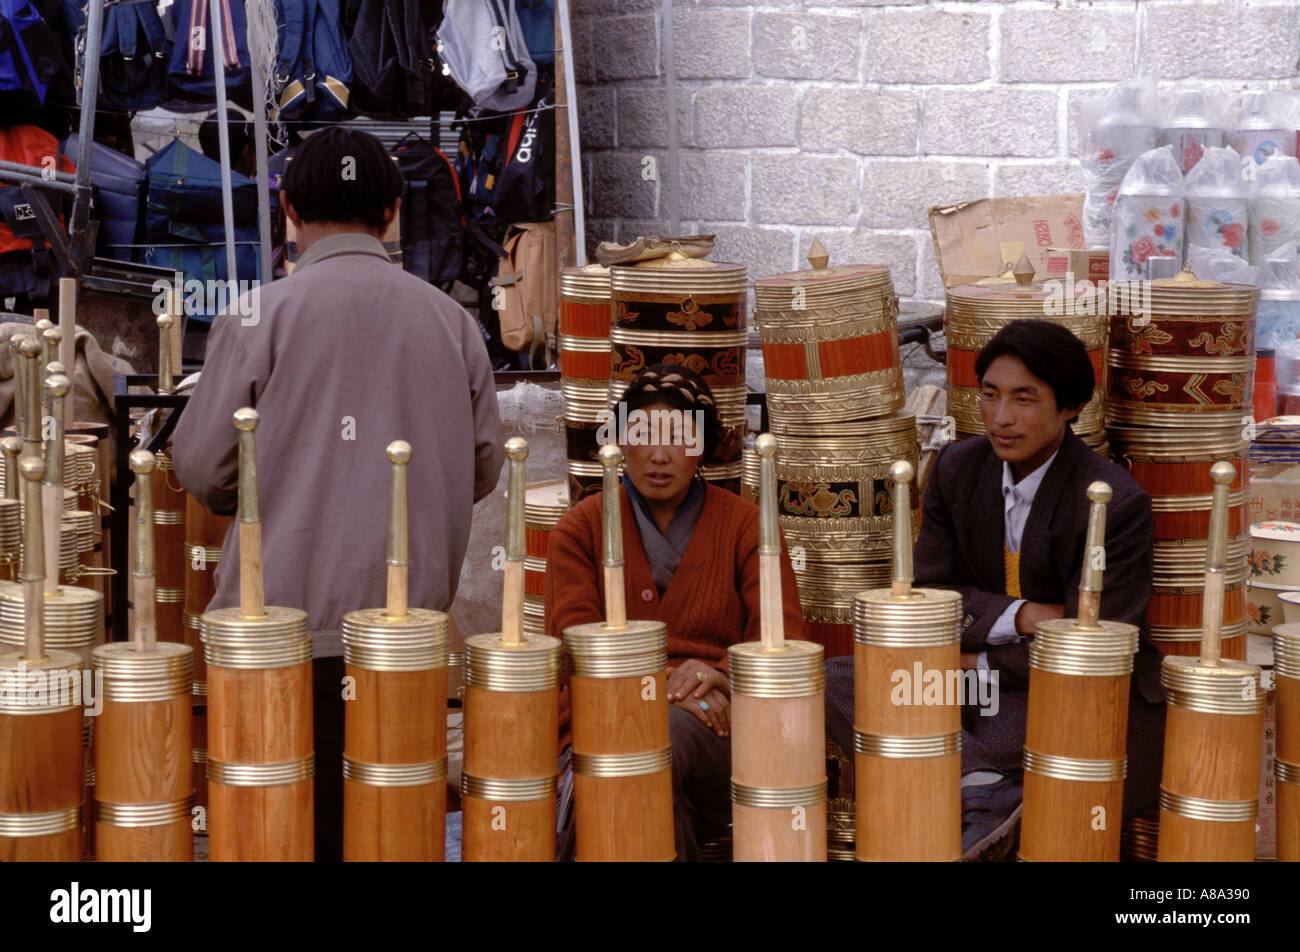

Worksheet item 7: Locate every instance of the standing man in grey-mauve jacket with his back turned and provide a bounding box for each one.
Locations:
[173,127,504,860]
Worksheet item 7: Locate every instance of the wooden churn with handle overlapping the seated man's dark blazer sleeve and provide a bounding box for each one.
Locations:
[1021,483,1138,862]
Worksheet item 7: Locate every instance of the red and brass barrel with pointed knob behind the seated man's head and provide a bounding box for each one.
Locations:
[944,259,1106,455]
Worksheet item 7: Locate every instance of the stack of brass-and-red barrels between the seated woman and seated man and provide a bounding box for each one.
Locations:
[754,242,919,658]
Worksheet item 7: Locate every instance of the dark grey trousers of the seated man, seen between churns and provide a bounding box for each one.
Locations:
[826,655,1165,818]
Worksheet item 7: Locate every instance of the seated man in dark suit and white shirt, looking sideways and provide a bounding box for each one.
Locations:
[826,320,1165,858]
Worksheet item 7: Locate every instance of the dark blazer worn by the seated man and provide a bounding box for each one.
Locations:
[914,429,1164,702]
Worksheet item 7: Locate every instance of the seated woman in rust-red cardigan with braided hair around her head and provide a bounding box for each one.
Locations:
[546,364,803,860]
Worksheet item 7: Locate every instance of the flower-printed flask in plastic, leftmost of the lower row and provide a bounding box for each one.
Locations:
[1110,146,1186,281]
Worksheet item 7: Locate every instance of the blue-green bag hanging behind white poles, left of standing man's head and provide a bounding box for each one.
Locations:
[143,139,260,306]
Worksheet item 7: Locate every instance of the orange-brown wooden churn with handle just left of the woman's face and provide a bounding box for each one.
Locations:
[564,443,676,861]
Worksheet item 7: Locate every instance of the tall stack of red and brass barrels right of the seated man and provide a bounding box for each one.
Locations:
[1106,272,1260,659]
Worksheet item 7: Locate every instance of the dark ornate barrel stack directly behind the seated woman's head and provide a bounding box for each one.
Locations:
[605,250,749,502]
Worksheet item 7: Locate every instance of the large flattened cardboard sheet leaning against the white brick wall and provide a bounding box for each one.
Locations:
[930,192,1083,287]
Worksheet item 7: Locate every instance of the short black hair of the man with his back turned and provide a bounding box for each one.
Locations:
[282,126,406,231]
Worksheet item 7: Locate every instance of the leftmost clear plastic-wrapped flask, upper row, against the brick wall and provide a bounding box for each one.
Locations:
[1075,78,1160,248]
